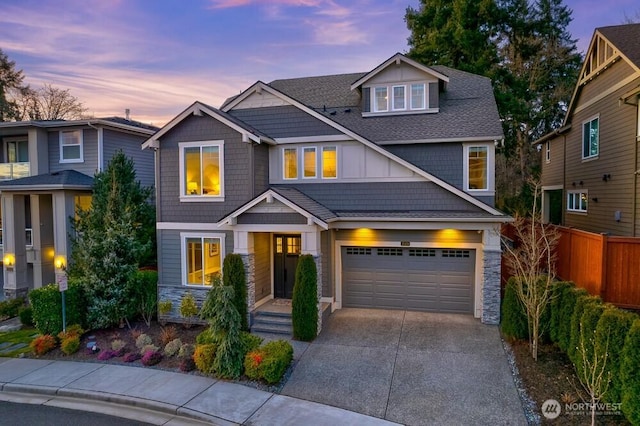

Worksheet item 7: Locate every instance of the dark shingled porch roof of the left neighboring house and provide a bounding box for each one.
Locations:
[0,170,93,191]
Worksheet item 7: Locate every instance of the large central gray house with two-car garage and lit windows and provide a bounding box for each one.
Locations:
[143,54,509,324]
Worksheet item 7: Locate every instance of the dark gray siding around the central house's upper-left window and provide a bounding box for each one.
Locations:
[158,115,254,223]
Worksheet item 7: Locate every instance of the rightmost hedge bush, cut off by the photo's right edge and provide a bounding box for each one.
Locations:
[620,319,640,425]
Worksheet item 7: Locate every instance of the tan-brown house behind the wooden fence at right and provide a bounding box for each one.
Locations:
[534,24,640,237]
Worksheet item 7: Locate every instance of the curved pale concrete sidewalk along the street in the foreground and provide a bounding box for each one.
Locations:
[0,358,394,425]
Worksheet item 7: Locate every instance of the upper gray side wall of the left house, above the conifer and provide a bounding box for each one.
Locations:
[102,129,155,187]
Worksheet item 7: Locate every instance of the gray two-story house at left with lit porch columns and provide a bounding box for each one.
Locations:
[0,117,158,298]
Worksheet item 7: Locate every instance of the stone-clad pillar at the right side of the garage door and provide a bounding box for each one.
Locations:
[482,224,502,324]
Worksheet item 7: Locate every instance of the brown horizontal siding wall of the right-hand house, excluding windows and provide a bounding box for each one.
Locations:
[564,61,638,236]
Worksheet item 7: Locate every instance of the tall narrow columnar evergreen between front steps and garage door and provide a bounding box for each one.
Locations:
[291,254,318,342]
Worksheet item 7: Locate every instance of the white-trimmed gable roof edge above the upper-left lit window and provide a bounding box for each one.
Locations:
[142,101,273,149]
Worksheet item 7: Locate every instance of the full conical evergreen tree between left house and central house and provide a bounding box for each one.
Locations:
[69,151,154,328]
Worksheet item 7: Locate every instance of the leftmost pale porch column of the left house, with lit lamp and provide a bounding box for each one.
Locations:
[2,194,29,299]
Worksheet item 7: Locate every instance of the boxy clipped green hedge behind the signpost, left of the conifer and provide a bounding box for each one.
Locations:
[29,280,86,335]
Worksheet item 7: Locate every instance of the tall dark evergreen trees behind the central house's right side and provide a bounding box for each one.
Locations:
[405,0,582,214]
